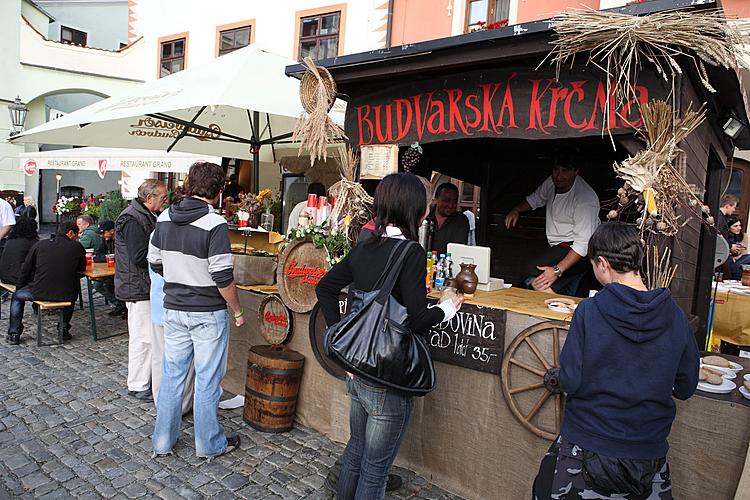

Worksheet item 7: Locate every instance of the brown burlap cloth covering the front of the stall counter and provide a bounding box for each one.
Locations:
[228,292,750,500]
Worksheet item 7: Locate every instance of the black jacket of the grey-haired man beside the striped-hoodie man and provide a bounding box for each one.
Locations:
[115,198,156,302]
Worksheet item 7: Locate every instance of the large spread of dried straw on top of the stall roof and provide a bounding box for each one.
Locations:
[545,9,750,133]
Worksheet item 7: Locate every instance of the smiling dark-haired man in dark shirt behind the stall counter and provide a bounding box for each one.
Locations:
[428,182,469,254]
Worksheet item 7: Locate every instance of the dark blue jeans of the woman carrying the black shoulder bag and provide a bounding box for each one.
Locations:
[336,377,414,500]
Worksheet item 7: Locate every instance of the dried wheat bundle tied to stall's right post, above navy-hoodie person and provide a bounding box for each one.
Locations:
[607,101,713,236]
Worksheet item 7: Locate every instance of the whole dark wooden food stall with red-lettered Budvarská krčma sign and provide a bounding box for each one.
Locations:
[238,0,750,499]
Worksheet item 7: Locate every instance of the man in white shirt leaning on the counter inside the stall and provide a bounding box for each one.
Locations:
[505,160,600,295]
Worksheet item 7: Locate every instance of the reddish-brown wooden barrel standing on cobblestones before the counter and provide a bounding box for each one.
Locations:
[243,345,305,432]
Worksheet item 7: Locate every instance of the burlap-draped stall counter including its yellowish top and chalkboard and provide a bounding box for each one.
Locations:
[223,286,750,500]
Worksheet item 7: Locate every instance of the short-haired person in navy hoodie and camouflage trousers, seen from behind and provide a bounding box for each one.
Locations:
[534,222,700,500]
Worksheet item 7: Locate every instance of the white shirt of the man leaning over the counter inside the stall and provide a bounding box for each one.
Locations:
[526,176,601,257]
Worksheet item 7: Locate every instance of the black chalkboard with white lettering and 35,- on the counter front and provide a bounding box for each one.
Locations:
[427,299,505,374]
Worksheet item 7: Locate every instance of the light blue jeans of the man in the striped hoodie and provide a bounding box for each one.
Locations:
[151,309,229,457]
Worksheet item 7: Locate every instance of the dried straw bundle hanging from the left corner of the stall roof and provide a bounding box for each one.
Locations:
[292,57,345,166]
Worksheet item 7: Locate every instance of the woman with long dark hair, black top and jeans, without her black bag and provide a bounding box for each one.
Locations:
[317,173,460,500]
